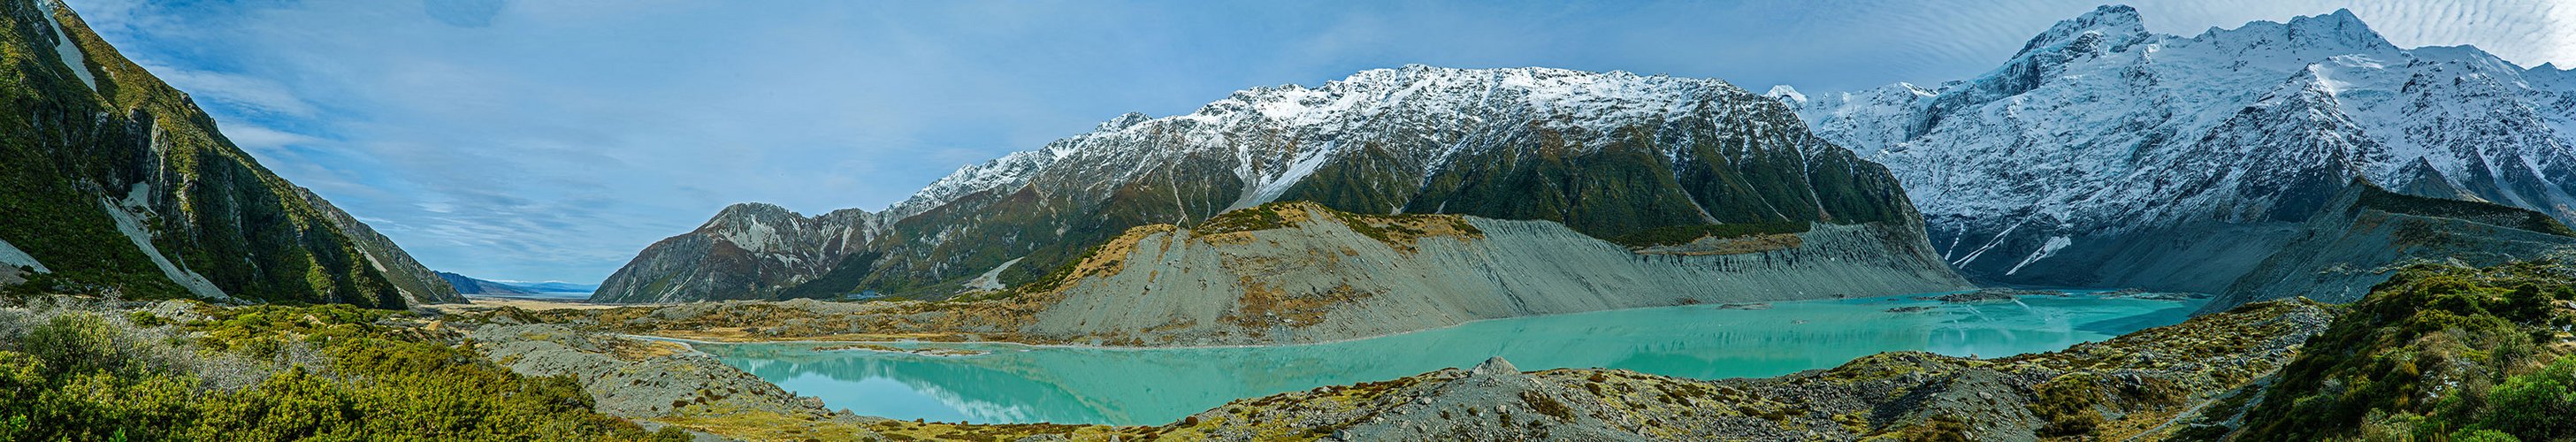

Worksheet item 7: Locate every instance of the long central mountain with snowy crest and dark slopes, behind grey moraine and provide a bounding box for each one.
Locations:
[598,67,1916,301]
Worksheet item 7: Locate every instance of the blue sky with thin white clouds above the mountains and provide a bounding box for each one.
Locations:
[67,0,2576,283]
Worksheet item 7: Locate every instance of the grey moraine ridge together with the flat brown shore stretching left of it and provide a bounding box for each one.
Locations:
[548,201,1970,347]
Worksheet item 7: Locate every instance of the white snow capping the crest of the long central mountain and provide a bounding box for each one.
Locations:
[886,65,1813,218]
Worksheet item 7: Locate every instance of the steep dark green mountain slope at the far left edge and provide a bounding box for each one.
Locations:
[0,0,461,309]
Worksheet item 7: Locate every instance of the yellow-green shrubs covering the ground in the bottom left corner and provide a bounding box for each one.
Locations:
[0,306,688,439]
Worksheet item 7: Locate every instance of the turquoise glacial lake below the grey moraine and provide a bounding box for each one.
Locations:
[696,293,2205,424]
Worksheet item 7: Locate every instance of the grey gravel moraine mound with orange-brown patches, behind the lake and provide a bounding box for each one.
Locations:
[1020,203,1968,345]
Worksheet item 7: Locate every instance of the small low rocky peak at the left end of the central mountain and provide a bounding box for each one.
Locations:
[590,203,878,303]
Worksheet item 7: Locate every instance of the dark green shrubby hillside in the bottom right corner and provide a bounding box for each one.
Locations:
[2238,263,2576,439]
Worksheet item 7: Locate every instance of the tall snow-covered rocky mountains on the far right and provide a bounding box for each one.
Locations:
[1770,5,2576,293]
